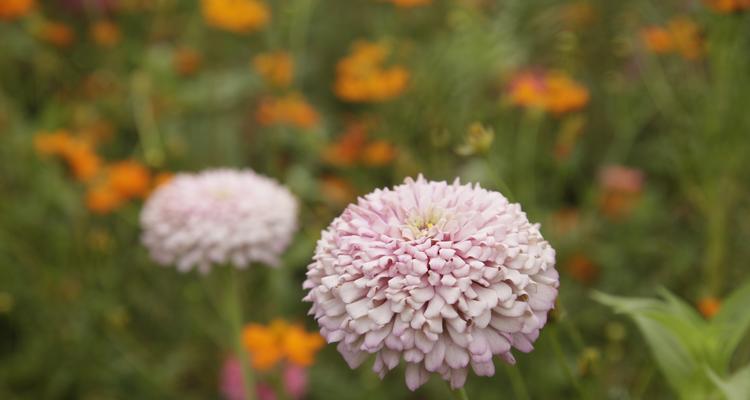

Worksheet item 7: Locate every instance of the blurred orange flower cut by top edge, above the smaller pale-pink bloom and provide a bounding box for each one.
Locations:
[201,0,271,33]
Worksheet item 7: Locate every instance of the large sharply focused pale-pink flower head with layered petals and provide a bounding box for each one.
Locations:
[304,176,559,390]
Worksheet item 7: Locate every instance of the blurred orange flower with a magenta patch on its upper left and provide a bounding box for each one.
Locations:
[510,71,589,114]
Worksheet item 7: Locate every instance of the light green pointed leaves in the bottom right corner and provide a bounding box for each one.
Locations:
[593,282,750,400]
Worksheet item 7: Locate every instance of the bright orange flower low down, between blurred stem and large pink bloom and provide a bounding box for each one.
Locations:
[242,319,324,371]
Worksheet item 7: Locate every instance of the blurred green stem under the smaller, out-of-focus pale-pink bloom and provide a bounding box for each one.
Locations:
[224,266,255,400]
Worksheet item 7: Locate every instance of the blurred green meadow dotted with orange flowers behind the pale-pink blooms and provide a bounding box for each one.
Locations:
[0,0,750,400]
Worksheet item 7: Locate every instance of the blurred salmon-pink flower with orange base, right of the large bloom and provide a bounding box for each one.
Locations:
[599,165,644,218]
